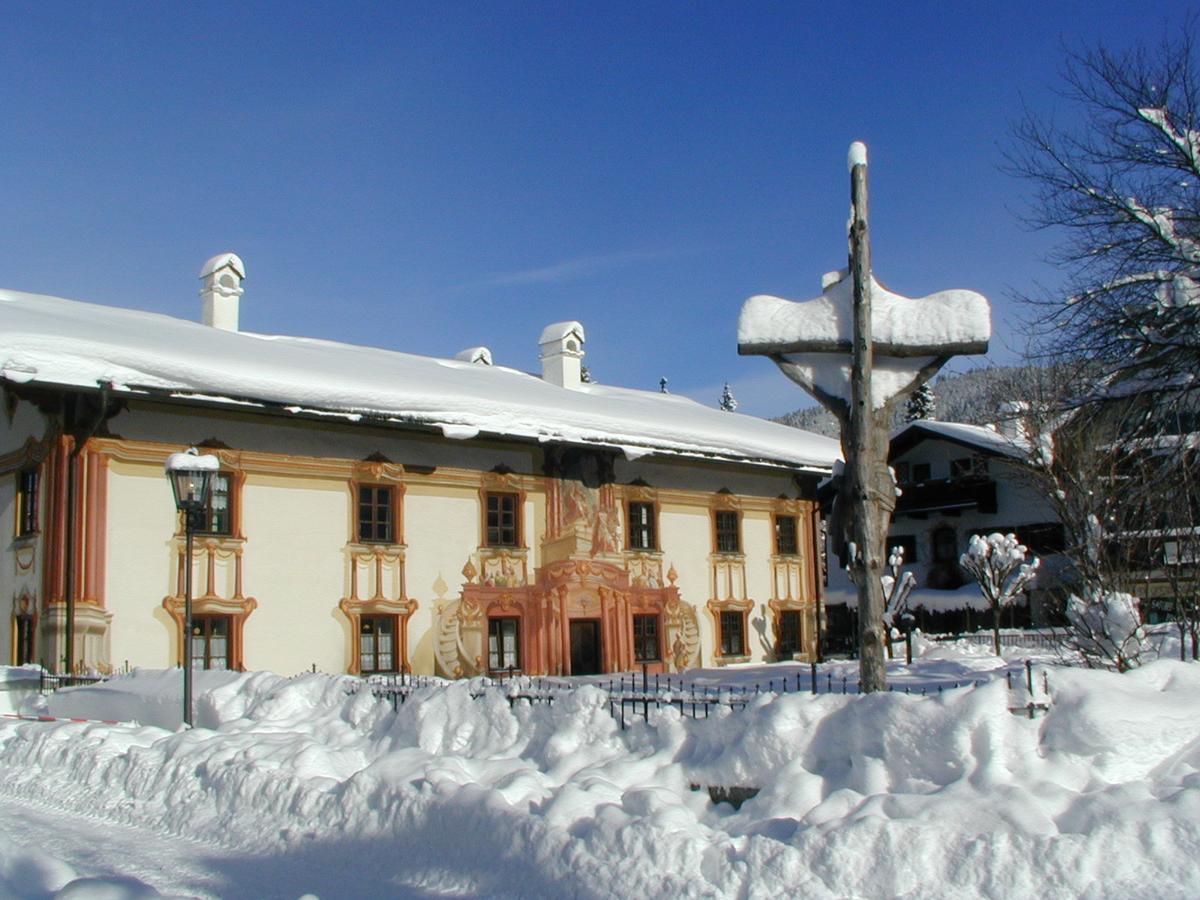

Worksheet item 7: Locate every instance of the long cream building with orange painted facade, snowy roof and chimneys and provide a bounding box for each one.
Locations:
[0,254,836,677]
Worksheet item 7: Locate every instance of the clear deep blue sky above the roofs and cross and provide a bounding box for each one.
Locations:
[0,1,1192,415]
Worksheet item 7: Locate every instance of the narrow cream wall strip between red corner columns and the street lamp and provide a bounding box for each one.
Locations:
[104,460,176,668]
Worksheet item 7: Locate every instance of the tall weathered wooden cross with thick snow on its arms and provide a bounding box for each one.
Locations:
[738,143,991,691]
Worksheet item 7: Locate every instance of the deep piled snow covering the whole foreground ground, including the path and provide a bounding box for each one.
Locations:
[0,646,1200,900]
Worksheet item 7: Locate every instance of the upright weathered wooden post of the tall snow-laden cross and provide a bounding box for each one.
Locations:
[842,144,888,694]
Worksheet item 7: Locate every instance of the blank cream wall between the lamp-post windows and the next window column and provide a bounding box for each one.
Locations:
[241,473,350,674]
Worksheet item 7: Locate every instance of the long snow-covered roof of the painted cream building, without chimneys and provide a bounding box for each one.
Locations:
[0,290,840,470]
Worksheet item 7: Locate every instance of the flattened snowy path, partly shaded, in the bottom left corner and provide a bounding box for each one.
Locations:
[0,790,494,900]
